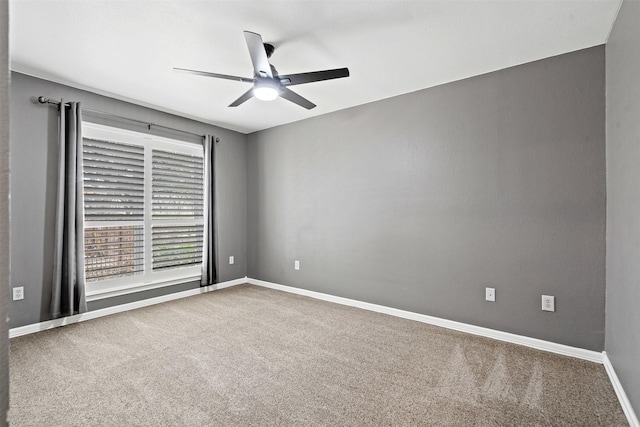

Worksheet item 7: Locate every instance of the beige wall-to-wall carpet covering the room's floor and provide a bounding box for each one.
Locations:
[10,285,627,427]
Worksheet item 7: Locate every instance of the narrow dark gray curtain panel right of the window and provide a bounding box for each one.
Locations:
[200,135,218,286]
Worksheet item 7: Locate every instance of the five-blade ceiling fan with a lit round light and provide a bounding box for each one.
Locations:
[174,31,349,110]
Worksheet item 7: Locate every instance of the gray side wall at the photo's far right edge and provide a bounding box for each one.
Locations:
[605,0,640,415]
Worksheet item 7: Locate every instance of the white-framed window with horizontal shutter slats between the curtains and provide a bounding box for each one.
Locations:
[82,122,207,300]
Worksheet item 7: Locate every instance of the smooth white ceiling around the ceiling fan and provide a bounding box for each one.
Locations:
[10,0,621,133]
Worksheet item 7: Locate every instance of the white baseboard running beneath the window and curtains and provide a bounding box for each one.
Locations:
[9,277,248,338]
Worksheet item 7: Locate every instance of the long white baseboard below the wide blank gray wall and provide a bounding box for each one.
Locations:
[247,278,602,363]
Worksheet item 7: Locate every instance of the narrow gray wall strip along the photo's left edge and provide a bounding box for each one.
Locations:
[0,1,10,427]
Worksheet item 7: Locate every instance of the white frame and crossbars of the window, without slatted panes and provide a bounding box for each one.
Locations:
[82,121,205,301]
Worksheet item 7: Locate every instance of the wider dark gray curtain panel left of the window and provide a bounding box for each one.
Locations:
[51,100,87,318]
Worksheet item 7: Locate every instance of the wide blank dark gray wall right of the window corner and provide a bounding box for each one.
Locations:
[247,46,606,351]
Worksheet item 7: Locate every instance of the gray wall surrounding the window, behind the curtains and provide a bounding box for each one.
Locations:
[10,73,247,327]
